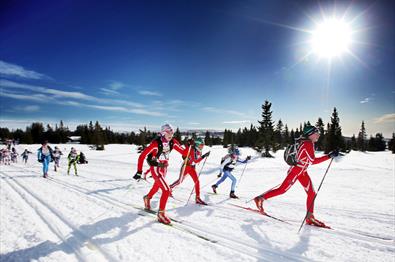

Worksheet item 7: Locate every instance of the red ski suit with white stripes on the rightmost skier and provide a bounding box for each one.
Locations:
[261,140,330,213]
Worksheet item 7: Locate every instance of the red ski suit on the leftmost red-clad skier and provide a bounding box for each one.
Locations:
[137,138,184,210]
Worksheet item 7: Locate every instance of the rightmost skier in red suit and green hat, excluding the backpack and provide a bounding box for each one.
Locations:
[254,125,339,227]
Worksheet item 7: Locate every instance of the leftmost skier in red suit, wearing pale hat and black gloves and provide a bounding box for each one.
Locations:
[133,124,185,224]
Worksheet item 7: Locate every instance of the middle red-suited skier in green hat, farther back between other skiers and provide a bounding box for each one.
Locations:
[170,138,210,205]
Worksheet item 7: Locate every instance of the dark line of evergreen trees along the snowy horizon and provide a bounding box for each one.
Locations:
[0,100,395,154]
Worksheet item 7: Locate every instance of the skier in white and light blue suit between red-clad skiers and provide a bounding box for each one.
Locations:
[211,145,251,198]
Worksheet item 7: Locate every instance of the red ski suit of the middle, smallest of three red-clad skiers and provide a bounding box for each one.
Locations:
[170,147,203,198]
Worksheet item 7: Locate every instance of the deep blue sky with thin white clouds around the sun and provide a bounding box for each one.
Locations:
[0,0,395,137]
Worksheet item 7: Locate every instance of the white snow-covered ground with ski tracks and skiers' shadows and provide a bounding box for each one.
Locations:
[0,145,395,262]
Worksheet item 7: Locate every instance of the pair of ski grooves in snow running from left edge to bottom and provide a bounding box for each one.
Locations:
[0,171,116,261]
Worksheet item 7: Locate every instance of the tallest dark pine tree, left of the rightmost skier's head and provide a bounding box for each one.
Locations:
[257,100,274,157]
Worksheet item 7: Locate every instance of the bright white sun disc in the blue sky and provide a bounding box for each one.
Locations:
[311,18,352,58]
